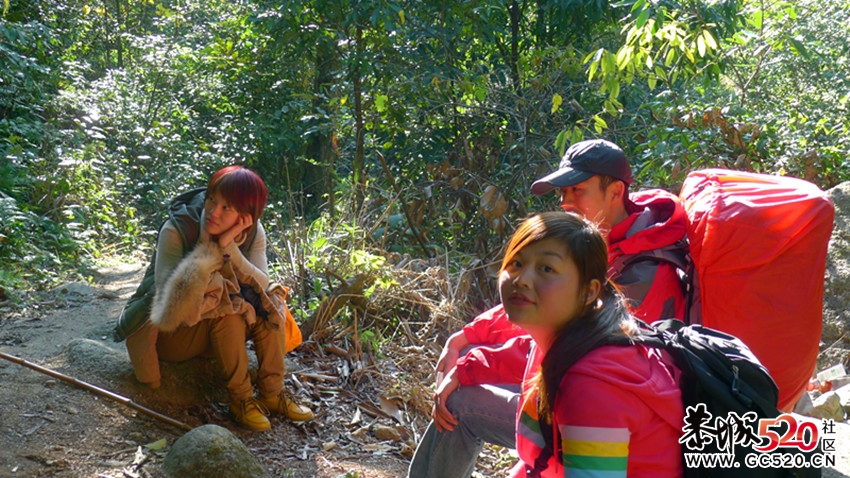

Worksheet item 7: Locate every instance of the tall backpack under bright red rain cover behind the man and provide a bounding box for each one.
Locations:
[680,169,835,411]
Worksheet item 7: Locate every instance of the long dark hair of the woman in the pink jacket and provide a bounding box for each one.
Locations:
[502,211,634,423]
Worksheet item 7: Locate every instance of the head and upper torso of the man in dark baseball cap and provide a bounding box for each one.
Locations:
[531,139,687,322]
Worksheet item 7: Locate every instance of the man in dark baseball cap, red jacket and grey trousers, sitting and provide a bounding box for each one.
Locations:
[408,139,687,478]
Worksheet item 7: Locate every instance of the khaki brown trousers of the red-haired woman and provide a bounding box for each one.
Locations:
[156,315,284,401]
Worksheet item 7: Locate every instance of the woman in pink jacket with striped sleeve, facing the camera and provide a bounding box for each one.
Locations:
[499,212,684,478]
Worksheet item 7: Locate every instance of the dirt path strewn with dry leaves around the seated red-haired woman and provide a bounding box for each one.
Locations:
[0,264,850,478]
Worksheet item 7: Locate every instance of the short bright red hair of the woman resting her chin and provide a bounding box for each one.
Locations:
[207,166,269,224]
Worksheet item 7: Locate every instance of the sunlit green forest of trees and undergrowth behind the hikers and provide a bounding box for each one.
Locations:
[0,0,850,349]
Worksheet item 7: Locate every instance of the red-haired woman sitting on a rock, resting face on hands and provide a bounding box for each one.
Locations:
[116,166,313,431]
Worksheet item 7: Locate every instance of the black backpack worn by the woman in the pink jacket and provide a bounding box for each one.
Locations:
[526,319,821,478]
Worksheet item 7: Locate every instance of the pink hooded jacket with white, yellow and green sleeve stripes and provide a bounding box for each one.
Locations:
[511,346,684,478]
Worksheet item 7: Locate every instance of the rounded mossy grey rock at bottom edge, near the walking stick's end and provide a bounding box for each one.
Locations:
[162,425,270,478]
